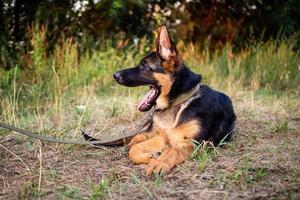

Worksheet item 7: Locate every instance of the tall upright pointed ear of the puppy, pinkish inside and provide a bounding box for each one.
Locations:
[156,26,181,73]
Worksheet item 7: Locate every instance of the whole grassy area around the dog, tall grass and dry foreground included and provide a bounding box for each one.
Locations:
[0,30,300,199]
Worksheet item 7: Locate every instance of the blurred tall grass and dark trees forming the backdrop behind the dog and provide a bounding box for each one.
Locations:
[0,0,300,124]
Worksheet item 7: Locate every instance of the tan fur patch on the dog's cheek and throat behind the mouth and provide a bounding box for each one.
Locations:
[153,73,173,110]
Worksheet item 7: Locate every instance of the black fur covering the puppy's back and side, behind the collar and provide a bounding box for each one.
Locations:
[179,85,236,144]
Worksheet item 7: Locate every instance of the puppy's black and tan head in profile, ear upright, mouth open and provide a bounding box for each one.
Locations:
[113,26,201,111]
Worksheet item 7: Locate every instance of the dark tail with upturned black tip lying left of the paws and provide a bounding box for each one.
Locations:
[81,130,136,147]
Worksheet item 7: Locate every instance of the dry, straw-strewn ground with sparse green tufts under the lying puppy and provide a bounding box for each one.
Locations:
[0,91,300,199]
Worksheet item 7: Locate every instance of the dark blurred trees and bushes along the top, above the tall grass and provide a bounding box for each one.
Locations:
[0,0,300,69]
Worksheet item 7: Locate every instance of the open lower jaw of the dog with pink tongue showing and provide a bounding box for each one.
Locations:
[137,85,159,112]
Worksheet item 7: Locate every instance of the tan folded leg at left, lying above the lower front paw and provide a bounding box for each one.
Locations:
[129,134,169,164]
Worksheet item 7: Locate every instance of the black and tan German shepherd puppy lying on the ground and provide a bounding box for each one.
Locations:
[113,26,236,175]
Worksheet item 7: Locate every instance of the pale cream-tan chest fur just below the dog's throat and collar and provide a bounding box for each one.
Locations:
[153,106,180,130]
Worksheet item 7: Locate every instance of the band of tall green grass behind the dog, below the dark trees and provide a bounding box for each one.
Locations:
[0,34,300,130]
